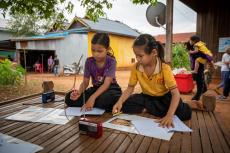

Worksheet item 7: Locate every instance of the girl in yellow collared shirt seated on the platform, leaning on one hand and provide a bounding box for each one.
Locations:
[113,34,191,127]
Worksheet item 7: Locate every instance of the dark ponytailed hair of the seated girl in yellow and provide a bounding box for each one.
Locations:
[133,34,165,62]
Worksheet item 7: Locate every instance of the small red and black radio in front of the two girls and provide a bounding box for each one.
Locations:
[79,118,103,138]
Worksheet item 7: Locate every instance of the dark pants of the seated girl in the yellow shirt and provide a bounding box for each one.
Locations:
[122,92,192,121]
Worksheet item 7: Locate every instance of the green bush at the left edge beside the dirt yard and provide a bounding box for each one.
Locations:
[0,59,25,85]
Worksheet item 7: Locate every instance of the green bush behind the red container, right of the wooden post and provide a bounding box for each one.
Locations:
[172,43,191,70]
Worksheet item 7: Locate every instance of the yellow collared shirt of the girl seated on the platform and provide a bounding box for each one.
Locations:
[129,60,177,96]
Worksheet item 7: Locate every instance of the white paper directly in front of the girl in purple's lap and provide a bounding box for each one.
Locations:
[60,107,105,116]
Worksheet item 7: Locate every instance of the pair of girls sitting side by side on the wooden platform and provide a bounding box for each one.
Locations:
[66,34,191,127]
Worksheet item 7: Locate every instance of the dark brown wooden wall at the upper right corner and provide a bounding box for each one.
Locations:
[180,0,230,77]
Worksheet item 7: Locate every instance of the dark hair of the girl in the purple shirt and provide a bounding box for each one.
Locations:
[91,33,115,58]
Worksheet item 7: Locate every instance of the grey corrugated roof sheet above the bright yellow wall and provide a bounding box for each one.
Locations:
[81,18,140,37]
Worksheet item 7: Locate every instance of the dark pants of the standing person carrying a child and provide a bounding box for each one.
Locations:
[192,64,207,100]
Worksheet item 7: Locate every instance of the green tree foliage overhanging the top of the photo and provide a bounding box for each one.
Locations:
[0,0,157,36]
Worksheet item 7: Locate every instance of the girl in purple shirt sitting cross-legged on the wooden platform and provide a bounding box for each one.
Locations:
[65,33,121,111]
